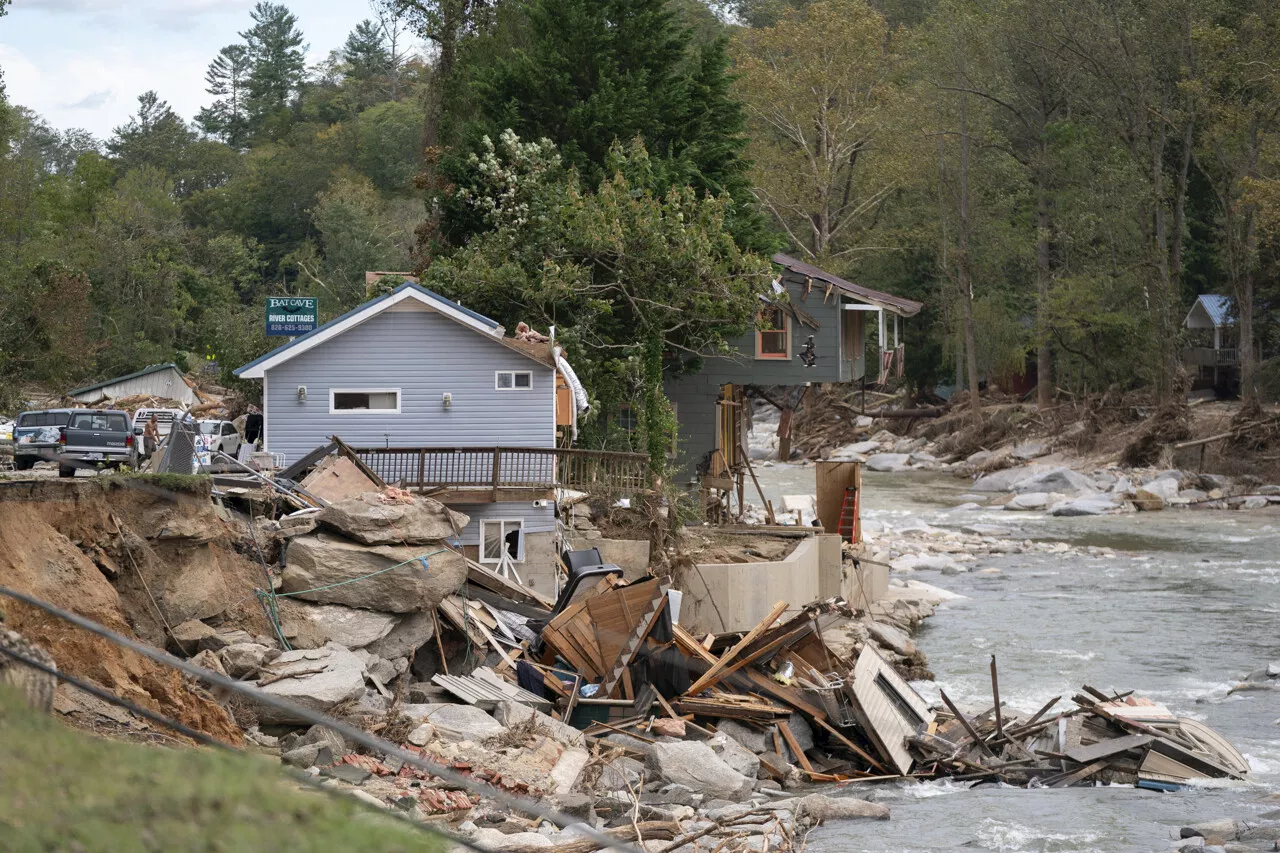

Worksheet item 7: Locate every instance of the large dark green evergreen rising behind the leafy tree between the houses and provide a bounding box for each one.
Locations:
[456,0,765,246]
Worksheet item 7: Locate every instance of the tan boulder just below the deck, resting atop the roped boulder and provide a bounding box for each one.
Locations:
[316,492,468,544]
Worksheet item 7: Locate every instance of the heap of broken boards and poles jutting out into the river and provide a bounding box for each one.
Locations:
[909,658,1249,790]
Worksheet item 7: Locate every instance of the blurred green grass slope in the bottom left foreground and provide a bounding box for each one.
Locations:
[0,686,444,853]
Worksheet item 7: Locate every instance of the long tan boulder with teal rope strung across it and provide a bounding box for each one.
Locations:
[282,534,467,613]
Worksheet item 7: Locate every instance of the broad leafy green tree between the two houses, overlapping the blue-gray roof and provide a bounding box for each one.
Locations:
[426,131,771,469]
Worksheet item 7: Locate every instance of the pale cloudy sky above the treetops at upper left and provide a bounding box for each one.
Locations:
[0,0,386,140]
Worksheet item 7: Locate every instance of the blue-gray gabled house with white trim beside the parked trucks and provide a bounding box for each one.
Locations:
[236,283,643,594]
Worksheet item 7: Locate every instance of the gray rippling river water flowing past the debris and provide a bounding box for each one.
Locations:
[760,465,1280,853]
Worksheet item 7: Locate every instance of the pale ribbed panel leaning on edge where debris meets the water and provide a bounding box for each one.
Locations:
[852,644,933,774]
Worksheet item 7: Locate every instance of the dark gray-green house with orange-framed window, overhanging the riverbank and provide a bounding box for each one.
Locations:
[663,254,923,484]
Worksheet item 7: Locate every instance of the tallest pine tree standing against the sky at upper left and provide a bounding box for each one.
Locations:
[241,0,306,133]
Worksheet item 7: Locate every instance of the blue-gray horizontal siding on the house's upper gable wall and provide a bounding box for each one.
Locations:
[262,302,556,462]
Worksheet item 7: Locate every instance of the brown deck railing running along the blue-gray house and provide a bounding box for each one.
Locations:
[355,447,649,492]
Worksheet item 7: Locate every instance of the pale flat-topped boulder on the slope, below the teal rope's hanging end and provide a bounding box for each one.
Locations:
[255,646,365,724]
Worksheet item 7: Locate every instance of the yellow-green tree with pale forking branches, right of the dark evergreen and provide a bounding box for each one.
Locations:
[735,0,901,263]
